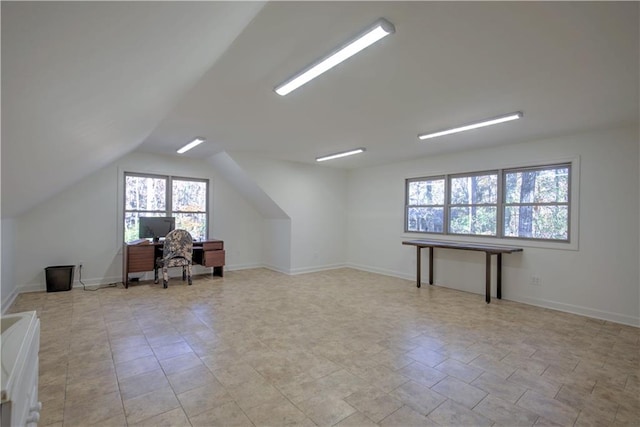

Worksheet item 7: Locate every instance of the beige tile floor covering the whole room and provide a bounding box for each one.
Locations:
[10,269,640,426]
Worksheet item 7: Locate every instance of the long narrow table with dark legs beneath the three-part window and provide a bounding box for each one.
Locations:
[402,240,523,304]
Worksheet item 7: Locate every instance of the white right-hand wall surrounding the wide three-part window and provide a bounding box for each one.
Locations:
[347,126,640,325]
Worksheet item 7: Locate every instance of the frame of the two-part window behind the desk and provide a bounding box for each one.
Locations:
[121,171,210,243]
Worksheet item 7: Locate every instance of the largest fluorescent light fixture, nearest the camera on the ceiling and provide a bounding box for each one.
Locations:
[274,18,396,96]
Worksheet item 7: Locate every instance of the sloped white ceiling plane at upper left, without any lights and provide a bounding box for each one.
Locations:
[1,1,264,218]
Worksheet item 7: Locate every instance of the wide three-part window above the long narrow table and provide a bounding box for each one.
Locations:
[405,163,571,242]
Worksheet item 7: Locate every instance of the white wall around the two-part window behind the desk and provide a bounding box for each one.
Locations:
[11,153,262,291]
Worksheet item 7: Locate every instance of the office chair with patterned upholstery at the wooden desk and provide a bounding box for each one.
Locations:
[154,230,193,288]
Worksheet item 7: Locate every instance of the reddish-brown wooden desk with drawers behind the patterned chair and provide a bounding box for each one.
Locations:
[122,239,224,288]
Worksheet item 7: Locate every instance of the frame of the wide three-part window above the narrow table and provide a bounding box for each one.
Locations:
[404,159,579,244]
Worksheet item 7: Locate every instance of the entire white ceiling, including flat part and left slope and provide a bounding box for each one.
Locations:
[2,2,639,217]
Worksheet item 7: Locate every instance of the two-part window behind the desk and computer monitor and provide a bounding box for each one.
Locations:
[124,173,209,242]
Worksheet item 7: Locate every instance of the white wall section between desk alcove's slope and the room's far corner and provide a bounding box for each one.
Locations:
[230,153,347,274]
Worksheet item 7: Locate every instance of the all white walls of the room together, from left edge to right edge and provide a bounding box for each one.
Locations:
[2,127,640,325]
